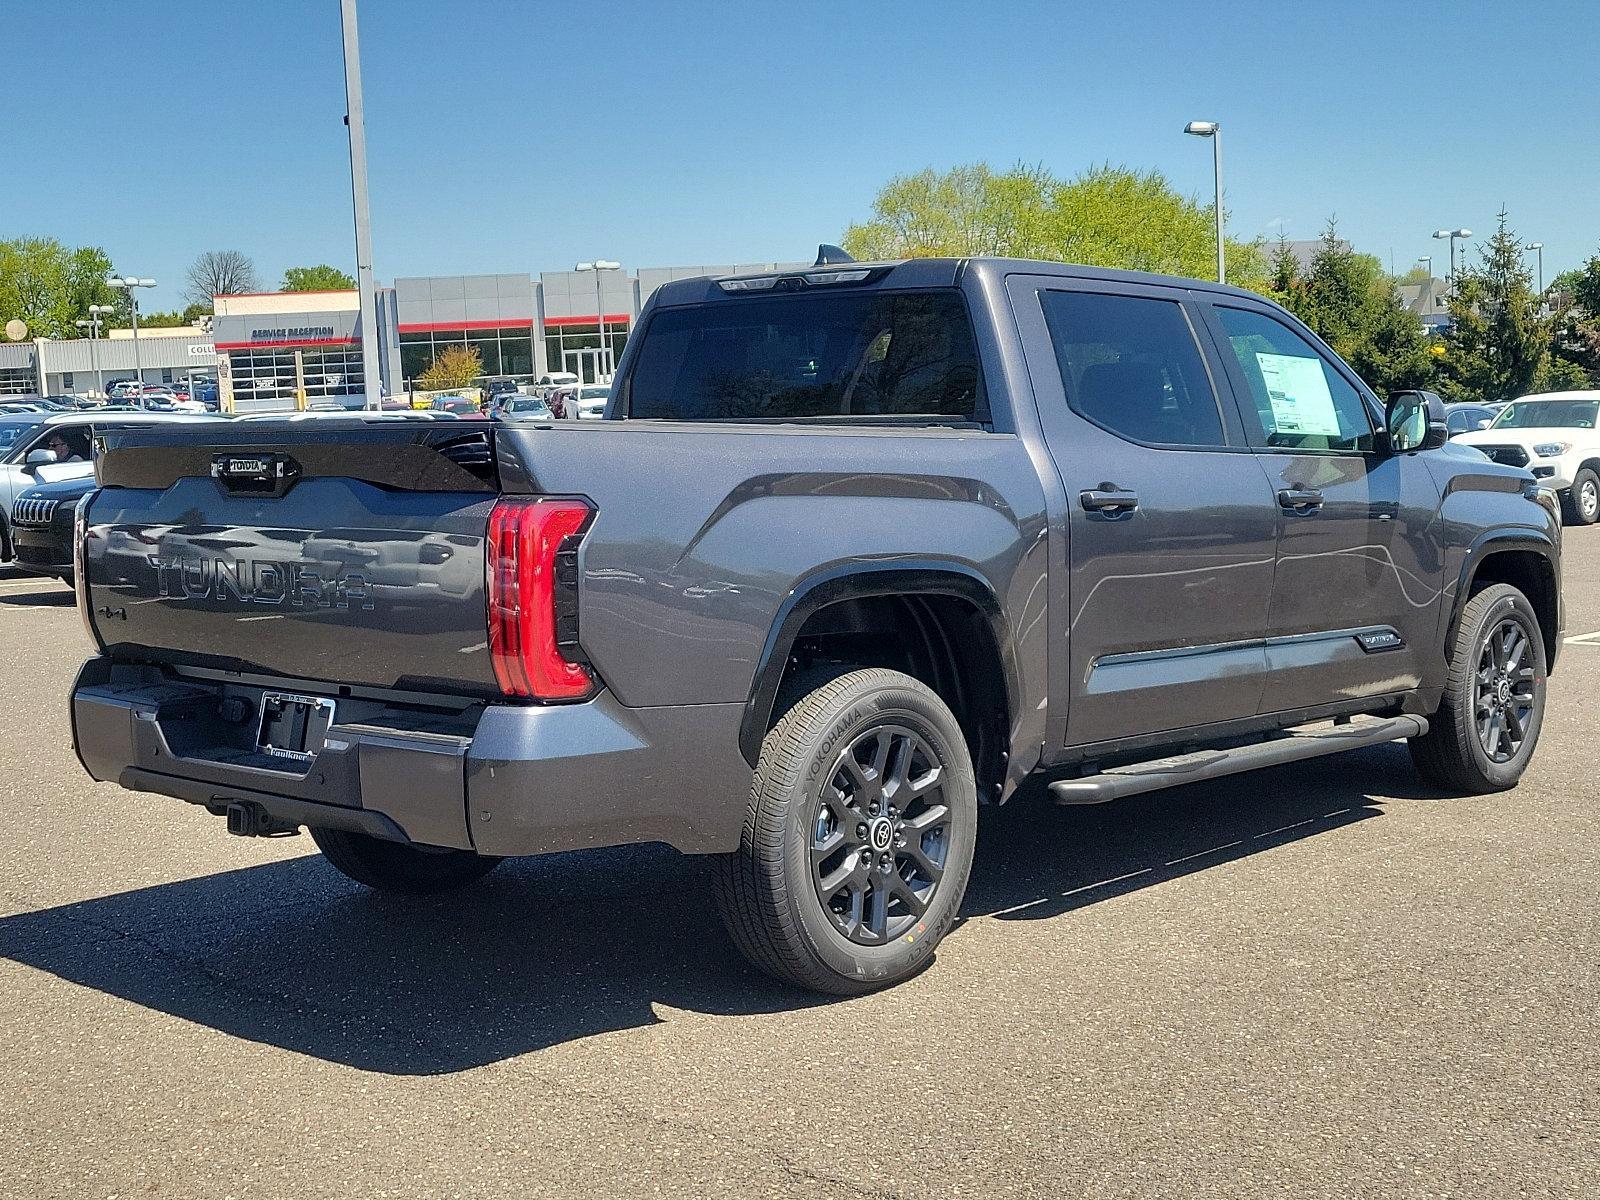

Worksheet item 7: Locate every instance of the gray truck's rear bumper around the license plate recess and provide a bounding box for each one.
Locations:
[72,658,750,854]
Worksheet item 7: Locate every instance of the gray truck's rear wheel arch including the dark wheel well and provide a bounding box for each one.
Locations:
[739,558,1022,798]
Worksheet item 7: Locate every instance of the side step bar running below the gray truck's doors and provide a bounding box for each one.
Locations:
[1050,714,1427,805]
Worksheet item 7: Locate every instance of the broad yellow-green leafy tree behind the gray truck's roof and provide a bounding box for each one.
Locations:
[843,163,1266,288]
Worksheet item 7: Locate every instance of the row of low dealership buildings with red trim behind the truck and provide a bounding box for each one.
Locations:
[0,262,803,413]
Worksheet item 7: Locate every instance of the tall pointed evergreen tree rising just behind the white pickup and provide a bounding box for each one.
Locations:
[1443,208,1555,402]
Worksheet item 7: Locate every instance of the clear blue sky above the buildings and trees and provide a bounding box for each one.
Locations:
[15,0,1600,307]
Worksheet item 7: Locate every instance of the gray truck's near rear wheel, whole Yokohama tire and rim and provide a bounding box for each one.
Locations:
[715,667,978,995]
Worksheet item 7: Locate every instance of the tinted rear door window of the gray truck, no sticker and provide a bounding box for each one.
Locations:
[1040,291,1224,446]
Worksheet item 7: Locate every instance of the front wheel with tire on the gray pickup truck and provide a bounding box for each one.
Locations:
[1411,584,1546,795]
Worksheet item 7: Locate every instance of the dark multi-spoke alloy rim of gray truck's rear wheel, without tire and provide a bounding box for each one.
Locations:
[811,725,952,946]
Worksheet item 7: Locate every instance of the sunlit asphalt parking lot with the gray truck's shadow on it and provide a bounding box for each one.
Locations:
[0,540,1600,1200]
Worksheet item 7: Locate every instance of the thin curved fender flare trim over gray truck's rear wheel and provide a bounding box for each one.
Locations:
[739,558,1021,768]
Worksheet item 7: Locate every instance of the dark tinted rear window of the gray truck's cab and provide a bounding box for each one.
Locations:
[624,291,986,421]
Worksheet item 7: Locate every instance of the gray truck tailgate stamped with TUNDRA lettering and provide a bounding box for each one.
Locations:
[80,418,499,694]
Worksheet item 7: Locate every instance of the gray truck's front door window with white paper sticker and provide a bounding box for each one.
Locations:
[1214,306,1374,451]
